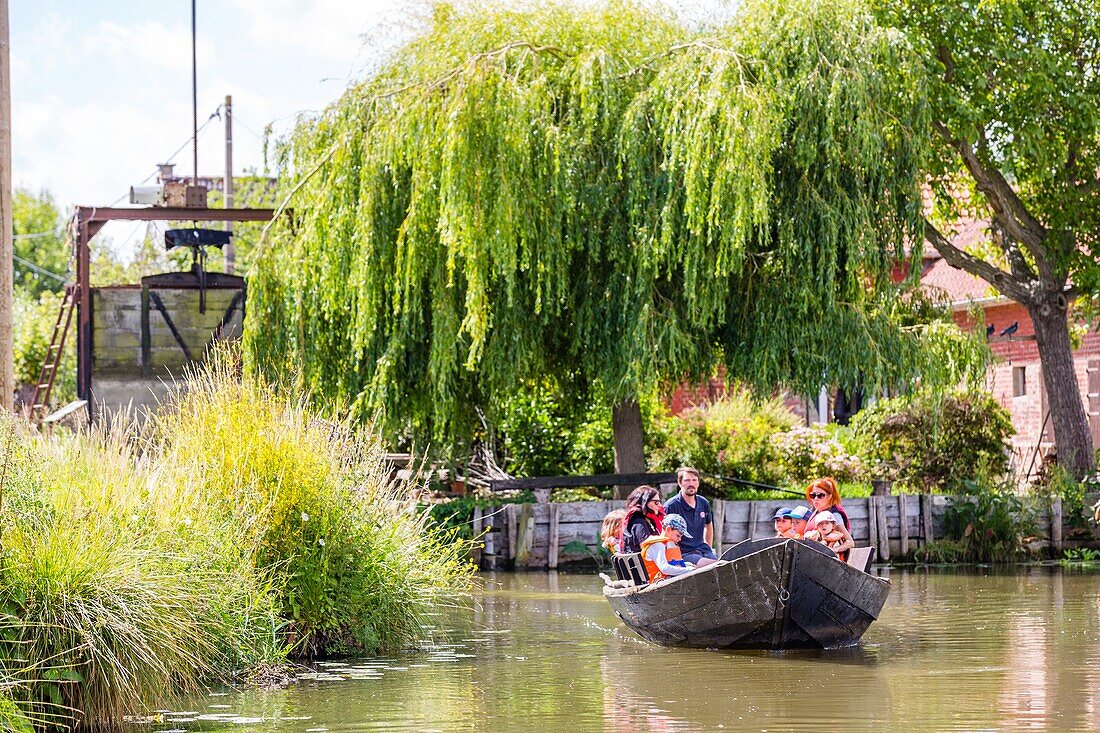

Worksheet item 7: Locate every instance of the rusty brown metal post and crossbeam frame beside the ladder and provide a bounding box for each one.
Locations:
[73,206,275,403]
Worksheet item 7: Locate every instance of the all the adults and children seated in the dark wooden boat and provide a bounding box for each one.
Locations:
[601,467,855,582]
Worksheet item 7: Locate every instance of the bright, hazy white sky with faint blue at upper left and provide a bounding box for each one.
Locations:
[9,0,725,256]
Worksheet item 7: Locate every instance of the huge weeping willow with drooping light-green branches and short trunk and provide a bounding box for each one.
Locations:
[245,0,990,471]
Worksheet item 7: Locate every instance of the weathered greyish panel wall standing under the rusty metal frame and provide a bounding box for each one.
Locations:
[91,286,244,415]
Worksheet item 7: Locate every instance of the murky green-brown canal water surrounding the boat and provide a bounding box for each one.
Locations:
[137,568,1100,733]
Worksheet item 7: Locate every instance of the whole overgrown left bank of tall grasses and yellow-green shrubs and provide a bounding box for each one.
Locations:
[0,367,470,729]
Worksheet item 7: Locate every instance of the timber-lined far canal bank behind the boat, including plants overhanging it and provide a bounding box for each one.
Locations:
[453,488,1100,570]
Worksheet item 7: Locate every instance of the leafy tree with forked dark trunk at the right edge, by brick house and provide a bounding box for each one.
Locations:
[877,0,1100,478]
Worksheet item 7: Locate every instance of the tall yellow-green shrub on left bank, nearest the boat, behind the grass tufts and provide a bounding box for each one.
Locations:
[153,362,469,655]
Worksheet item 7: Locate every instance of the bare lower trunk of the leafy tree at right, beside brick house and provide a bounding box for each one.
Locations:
[1027,302,1096,480]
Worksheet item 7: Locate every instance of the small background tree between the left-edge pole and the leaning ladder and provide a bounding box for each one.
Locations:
[11,188,69,300]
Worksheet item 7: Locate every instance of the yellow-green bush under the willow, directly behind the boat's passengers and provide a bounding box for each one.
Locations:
[650,390,796,493]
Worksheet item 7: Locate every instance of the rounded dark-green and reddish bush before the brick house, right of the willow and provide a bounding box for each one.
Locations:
[851,392,1014,493]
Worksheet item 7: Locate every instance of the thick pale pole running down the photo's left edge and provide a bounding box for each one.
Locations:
[0,0,15,413]
